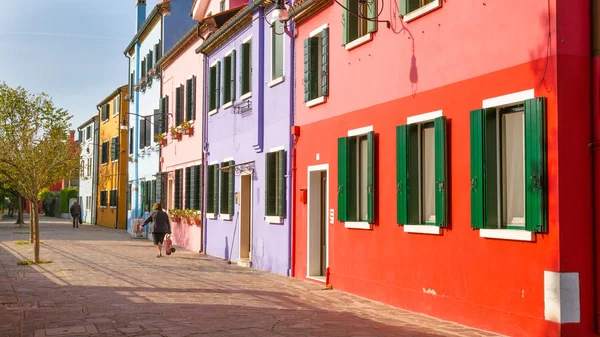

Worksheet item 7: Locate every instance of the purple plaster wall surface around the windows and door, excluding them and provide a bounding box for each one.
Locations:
[205,10,293,275]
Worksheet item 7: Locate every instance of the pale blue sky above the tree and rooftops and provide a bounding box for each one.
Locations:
[0,0,160,129]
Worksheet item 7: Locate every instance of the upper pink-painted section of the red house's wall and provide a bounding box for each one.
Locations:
[295,0,556,125]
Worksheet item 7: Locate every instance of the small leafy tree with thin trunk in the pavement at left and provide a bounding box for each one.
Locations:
[0,82,79,263]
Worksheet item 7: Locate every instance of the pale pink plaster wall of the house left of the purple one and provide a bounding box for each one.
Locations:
[161,39,204,251]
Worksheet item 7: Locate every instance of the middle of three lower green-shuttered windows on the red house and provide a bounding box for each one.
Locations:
[396,116,447,227]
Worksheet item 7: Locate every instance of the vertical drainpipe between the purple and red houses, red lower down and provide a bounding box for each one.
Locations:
[288,20,298,277]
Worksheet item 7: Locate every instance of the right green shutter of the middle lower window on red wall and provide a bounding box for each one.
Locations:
[433,116,448,227]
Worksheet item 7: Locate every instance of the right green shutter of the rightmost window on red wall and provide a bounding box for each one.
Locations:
[525,97,548,232]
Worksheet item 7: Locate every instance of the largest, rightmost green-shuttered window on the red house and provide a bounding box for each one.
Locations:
[471,98,547,232]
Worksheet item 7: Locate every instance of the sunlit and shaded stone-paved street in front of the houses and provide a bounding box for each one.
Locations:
[0,218,496,337]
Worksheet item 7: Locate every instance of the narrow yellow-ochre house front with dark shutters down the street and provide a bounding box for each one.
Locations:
[95,85,129,229]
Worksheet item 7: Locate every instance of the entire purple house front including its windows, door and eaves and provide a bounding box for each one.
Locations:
[197,1,294,275]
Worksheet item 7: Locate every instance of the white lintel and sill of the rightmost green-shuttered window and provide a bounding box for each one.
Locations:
[479,89,535,242]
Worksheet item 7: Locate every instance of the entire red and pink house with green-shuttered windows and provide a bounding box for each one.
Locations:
[291,0,596,336]
